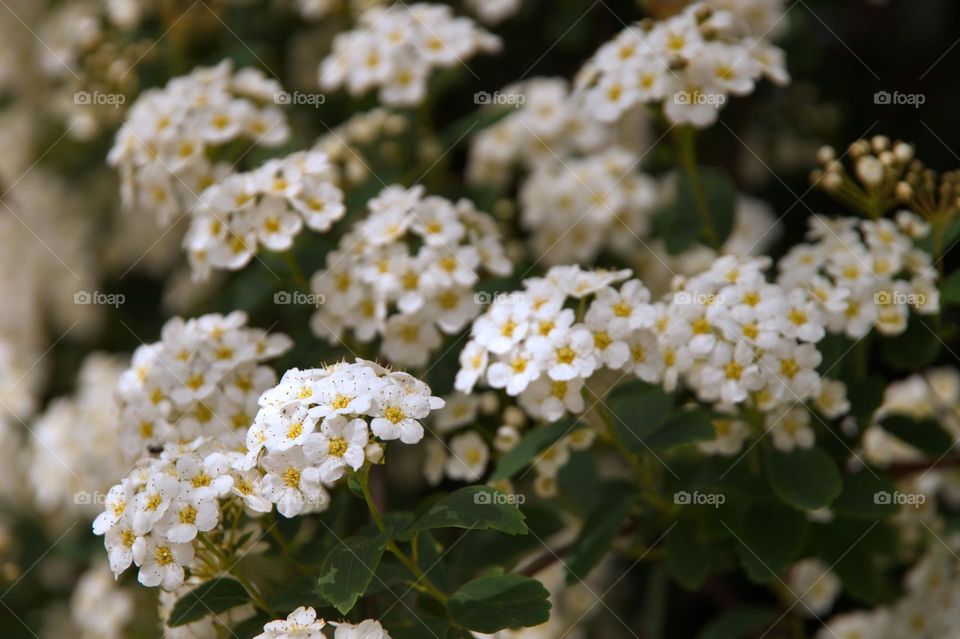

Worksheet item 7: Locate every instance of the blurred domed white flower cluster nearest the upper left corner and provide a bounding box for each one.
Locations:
[108,61,289,224]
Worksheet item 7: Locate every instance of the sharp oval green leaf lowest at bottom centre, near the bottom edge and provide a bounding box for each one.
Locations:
[448,575,550,633]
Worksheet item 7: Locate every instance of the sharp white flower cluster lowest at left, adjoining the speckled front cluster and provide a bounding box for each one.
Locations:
[93,437,251,590]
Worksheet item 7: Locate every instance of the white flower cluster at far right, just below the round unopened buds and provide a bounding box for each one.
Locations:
[778,211,940,339]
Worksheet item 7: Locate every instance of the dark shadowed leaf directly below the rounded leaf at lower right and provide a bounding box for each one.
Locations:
[737,504,808,583]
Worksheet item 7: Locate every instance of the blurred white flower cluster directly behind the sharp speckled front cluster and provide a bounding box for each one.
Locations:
[119,311,291,460]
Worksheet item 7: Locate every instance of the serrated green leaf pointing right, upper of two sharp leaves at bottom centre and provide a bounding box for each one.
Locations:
[398,486,527,540]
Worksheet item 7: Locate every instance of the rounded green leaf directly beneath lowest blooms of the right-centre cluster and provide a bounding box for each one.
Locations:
[767,448,843,510]
